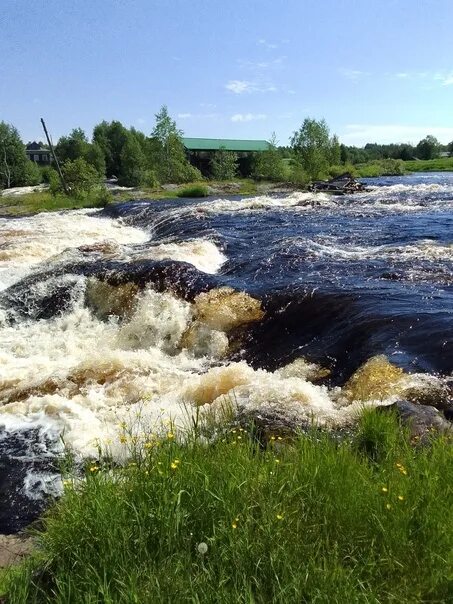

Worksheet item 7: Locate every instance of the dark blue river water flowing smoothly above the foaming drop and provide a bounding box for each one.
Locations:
[105,173,453,377]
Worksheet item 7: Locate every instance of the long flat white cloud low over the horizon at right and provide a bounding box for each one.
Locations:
[339,124,453,145]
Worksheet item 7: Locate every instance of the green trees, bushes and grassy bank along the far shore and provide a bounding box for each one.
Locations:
[0,106,453,214]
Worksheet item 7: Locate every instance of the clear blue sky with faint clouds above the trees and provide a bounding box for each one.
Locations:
[0,0,453,145]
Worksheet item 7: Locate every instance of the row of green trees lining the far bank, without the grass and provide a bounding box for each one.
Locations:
[0,105,453,194]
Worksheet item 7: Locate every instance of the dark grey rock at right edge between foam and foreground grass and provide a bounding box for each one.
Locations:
[378,400,453,442]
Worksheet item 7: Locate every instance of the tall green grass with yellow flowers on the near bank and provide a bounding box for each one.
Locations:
[6,411,453,604]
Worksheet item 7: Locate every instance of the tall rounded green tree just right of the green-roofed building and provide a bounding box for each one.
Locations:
[291,118,340,180]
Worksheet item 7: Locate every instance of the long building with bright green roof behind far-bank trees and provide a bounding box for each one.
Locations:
[182,138,269,176]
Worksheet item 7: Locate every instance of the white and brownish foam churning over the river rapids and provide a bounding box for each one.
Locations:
[0,193,449,472]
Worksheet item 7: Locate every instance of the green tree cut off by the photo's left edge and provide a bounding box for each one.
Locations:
[0,122,29,189]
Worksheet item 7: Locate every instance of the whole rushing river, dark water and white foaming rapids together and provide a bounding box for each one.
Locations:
[0,173,453,532]
